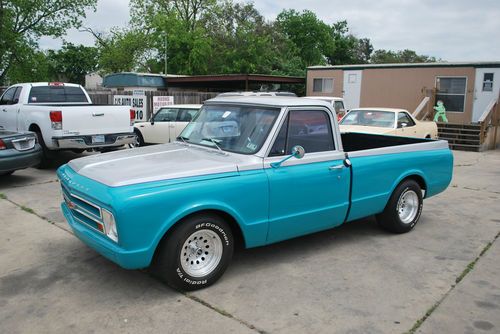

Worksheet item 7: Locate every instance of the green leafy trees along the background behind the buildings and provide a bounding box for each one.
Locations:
[0,0,436,85]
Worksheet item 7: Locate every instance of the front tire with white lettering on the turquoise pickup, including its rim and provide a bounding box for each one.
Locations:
[152,214,234,291]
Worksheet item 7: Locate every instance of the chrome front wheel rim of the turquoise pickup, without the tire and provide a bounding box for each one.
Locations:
[180,229,223,277]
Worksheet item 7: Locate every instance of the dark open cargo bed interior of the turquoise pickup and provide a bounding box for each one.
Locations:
[341,132,435,152]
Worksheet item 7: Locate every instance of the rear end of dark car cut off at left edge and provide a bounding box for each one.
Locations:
[0,130,42,175]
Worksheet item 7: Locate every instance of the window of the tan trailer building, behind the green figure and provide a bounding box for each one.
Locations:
[436,77,467,112]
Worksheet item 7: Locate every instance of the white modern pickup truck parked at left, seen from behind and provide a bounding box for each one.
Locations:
[0,82,135,165]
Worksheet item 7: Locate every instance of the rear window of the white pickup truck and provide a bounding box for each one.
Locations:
[28,86,89,103]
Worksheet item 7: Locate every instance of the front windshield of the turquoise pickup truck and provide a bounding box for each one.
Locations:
[179,105,280,154]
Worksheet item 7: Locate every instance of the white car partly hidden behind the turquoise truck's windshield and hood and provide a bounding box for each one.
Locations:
[130,104,201,147]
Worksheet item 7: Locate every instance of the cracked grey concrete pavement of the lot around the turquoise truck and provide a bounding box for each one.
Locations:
[0,150,500,333]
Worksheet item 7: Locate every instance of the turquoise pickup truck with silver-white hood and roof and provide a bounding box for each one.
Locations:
[57,97,453,290]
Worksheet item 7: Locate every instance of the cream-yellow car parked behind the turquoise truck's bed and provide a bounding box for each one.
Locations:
[340,108,438,139]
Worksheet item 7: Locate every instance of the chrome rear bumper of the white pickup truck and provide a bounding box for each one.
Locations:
[52,133,135,149]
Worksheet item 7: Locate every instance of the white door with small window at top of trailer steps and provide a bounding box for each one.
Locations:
[472,68,500,122]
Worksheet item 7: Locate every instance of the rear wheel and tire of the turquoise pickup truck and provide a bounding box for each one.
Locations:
[377,180,423,233]
